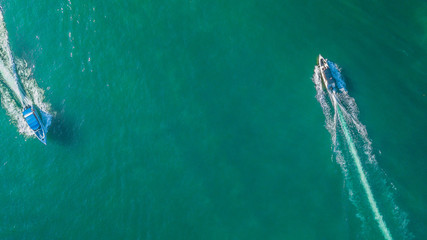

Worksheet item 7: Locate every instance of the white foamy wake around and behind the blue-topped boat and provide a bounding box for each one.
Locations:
[0,7,52,137]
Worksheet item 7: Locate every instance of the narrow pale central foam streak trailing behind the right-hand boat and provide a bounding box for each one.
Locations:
[335,101,393,240]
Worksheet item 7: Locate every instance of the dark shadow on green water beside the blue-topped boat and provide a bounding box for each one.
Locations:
[47,109,77,146]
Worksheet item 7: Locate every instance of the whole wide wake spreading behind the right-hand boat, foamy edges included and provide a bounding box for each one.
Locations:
[312,62,413,240]
